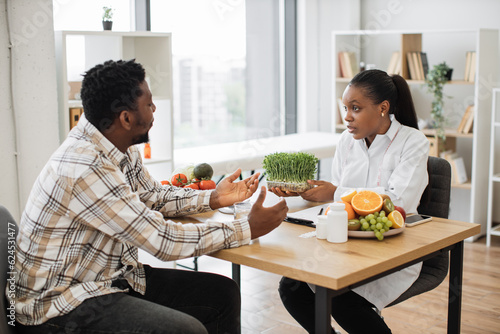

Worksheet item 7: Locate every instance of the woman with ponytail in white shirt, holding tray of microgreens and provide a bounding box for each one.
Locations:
[271,70,429,333]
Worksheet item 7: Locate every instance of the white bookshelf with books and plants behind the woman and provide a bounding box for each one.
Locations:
[331,29,499,241]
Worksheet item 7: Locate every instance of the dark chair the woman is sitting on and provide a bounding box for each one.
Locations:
[387,157,451,307]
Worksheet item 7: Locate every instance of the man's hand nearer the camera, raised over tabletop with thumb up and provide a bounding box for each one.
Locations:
[248,186,288,239]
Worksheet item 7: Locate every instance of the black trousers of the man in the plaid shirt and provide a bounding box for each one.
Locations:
[16,266,241,334]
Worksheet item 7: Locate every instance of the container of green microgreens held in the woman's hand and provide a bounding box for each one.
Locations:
[262,152,319,192]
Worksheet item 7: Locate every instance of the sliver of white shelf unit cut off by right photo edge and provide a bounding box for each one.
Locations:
[486,88,500,247]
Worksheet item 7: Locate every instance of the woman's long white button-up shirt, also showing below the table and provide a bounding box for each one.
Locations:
[332,115,429,310]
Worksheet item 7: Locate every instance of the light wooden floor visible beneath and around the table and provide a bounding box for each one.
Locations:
[140,237,500,334]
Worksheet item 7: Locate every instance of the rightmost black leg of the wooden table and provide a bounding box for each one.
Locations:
[448,241,464,334]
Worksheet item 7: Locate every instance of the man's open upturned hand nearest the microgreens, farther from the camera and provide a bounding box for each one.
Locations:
[210,168,260,210]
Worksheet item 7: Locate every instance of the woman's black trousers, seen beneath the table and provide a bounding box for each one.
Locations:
[279,277,391,334]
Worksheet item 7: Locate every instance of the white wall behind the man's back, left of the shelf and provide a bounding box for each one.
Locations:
[0,0,59,220]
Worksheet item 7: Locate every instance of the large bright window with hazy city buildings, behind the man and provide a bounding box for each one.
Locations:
[151,0,292,148]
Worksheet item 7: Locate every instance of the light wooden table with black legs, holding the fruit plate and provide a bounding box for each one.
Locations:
[199,193,480,333]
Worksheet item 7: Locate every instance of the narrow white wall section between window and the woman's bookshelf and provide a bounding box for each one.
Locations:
[297,0,360,132]
